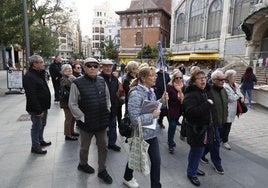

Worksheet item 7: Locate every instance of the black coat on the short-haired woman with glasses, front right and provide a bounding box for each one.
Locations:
[183,85,216,146]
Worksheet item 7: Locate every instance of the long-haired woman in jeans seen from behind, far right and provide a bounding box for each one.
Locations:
[241,67,257,108]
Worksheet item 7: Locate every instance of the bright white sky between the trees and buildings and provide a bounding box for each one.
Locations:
[63,0,131,36]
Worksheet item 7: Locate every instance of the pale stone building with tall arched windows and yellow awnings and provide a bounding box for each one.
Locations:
[171,0,268,67]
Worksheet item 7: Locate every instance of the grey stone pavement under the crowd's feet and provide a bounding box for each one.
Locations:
[0,71,268,188]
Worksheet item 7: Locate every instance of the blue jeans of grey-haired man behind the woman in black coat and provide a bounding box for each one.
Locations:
[203,125,223,166]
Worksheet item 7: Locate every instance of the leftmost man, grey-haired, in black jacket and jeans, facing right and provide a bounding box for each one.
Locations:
[23,55,51,154]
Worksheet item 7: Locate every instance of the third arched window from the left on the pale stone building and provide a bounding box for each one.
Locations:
[207,0,223,39]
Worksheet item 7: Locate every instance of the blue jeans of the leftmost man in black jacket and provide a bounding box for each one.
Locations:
[30,110,47,148]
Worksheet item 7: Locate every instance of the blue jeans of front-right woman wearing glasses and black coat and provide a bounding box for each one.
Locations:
[187,146,205,177]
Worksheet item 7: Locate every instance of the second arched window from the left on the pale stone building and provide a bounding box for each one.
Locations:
[188,0,205,41]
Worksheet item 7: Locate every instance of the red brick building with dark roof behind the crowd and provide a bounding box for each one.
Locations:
[116,0,171,63]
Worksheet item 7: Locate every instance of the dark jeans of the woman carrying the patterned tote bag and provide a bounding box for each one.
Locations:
[124,137,161,188]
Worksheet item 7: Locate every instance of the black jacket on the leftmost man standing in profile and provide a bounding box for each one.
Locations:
[23,68,51,115]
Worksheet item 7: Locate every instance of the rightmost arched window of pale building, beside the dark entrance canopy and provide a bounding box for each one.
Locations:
[232,0,251,35]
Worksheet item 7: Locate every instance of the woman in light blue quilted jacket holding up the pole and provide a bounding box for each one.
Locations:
[123,66,168,188]
